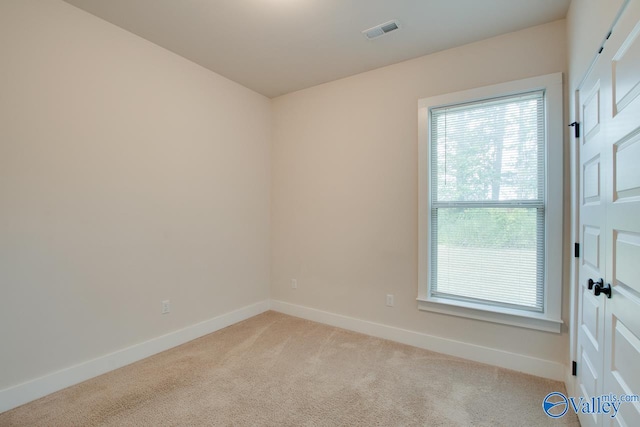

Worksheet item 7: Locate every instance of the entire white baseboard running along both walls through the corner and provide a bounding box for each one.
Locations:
[0,300,570,412]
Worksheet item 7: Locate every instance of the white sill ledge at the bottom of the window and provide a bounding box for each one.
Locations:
[418,298,563,334]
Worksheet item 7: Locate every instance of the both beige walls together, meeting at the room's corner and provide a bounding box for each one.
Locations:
[0,0,578,389]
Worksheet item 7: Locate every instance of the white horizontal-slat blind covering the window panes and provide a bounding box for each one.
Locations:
[429,90,544,312]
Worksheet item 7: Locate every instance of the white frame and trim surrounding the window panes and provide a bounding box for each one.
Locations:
[418,73,564,333]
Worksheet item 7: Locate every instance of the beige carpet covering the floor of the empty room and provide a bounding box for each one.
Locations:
[0,312,579,427]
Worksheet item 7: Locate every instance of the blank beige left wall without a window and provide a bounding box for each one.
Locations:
[0,0,271,389]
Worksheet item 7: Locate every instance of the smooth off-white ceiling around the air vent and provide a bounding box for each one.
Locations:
[65,0,570,97]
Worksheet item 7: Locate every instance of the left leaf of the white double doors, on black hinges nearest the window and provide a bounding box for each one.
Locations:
[576,55,609,427]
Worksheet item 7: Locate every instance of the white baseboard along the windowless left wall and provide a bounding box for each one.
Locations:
[0,300,269,413]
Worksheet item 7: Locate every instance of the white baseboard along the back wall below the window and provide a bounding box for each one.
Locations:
[271,300,566,382]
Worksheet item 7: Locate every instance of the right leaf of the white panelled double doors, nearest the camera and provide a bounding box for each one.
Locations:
[602,0,640,426]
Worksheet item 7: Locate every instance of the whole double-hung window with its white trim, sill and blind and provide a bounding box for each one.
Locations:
[418,74,562,332]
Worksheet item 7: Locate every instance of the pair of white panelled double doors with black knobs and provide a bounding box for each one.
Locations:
[577,0,640,426]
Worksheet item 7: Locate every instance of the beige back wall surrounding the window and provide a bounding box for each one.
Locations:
[271,21,570,364]
